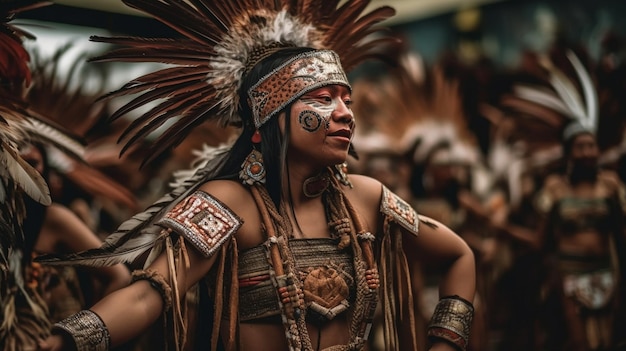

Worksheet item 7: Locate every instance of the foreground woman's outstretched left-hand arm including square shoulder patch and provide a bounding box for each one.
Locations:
[41,181,249,351]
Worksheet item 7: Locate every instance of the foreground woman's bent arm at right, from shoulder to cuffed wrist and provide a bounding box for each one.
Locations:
[346,175,476,351]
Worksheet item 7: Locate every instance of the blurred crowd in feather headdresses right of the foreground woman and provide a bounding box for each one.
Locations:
[349,33,626,350]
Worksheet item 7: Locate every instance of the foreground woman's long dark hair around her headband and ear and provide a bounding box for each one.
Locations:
[218,47,315,206]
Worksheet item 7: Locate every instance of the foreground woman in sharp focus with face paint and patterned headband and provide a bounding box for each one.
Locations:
[35,1,475,351]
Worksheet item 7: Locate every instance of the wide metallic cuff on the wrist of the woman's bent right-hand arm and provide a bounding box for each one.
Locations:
[427,296,474,351]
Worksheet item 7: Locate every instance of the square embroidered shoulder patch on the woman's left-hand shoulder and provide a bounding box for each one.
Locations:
[157,191,243,257]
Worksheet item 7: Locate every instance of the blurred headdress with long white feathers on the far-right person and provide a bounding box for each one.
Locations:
[483,50,600,205]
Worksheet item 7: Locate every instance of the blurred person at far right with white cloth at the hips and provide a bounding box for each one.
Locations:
[537,122,626,351]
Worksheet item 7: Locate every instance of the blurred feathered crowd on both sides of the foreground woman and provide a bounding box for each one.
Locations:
[0,0,626,351]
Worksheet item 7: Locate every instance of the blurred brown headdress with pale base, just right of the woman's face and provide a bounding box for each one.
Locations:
[355,53,479,172]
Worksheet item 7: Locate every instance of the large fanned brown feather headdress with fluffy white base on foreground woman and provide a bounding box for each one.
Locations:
[87,0,396,166]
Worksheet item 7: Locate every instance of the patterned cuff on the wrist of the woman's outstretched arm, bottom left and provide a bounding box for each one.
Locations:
[52,310,111,351]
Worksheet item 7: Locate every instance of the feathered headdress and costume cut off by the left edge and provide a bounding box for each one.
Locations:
[0,0,50,351]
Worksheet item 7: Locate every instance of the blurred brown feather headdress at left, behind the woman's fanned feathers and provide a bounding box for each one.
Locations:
[26,44,137,211]
